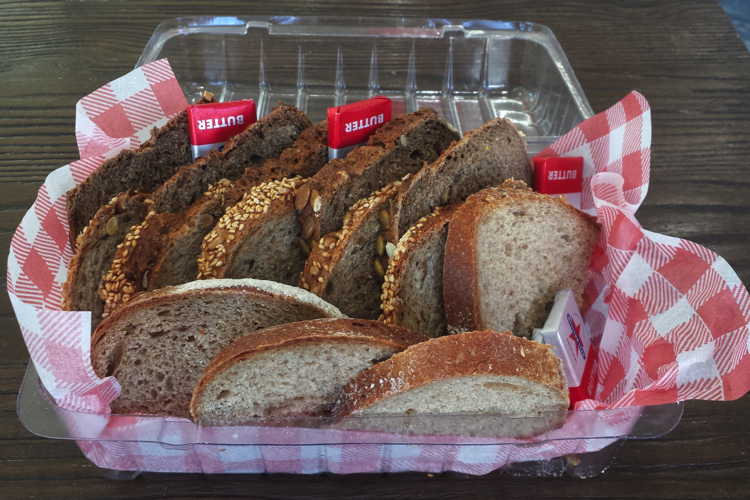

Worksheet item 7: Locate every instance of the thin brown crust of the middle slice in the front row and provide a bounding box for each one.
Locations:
[190,318,427,421]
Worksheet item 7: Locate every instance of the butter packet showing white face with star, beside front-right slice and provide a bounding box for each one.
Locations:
[532,290,594,408]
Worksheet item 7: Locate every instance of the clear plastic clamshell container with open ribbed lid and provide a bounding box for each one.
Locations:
[18,17,683,477]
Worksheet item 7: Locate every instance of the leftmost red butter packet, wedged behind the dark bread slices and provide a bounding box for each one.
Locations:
[187,99,257,159]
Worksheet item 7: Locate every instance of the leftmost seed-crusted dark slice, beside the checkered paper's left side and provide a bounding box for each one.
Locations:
[63,189,151,327]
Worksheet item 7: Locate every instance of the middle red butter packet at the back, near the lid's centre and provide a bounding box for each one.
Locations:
[328,96,393,158]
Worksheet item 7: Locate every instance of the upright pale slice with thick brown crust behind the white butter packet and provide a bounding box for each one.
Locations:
[443,181,599,336]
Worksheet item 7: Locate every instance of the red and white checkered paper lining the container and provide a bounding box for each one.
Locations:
[7,60,750,474]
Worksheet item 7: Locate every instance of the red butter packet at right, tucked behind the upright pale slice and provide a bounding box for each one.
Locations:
[534,156,583,210]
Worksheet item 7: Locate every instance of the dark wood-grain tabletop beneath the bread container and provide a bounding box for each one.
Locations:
[0,0,750,499]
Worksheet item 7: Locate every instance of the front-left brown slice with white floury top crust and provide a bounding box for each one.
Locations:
[91,280,341,417]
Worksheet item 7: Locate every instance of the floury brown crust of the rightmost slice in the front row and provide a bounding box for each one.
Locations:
[333,330,568,417]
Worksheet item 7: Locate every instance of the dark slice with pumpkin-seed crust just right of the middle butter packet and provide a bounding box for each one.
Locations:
[295,109,459,246]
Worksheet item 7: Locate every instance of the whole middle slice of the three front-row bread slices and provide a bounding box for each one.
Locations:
[190,319,426,425]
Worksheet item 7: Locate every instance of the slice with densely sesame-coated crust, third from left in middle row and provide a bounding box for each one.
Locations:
[197,176,308,285]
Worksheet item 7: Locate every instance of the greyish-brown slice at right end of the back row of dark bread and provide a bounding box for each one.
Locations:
[387,118,533,242]
